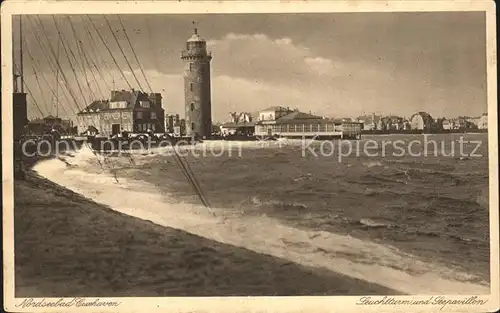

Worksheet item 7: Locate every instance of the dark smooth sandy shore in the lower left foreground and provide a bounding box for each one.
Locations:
[14,171,399,297]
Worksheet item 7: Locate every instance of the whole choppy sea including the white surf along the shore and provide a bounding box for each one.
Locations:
[35,134,489,294]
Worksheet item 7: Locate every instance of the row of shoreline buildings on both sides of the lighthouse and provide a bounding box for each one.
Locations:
[27,89,488,137]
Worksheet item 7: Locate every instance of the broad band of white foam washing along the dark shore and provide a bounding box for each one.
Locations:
[34,145,489,294]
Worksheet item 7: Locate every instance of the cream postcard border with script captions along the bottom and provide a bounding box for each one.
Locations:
[1,1,500,312]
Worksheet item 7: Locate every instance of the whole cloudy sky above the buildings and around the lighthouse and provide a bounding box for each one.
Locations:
[13,12,487,121]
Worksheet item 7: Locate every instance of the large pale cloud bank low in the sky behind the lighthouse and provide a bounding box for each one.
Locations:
[27,27,480,121]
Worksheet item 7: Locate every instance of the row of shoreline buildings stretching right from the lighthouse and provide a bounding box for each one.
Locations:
[220,106,488,137]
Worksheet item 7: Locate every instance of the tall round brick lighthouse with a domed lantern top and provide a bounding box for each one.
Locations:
[181,28,212,138]
